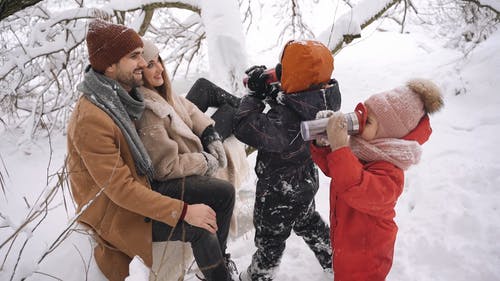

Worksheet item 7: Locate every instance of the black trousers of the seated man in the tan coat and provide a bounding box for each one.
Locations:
[152,176,235,281]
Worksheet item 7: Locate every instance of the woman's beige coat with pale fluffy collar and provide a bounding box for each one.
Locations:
[136,87,214,180]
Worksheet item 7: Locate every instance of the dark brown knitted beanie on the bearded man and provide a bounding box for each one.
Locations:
[87,19,143,73]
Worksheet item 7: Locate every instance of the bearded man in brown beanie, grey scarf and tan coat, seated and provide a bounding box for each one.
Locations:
[67,20,234,281]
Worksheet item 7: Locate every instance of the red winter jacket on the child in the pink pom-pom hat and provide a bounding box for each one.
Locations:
[311,116,432,281]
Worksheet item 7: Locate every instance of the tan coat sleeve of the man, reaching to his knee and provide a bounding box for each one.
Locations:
[71,108,184,226]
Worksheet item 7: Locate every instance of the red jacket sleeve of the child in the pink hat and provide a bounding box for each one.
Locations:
[327,147,404,219]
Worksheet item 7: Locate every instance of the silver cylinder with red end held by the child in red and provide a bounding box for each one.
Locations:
[300,103,367,141]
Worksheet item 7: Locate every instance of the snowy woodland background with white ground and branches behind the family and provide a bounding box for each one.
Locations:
[0,0,500,281]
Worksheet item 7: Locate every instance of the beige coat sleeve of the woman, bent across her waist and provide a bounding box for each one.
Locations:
[139,110,208,180]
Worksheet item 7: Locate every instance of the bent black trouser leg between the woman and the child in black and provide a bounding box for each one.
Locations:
[186,78,241,140]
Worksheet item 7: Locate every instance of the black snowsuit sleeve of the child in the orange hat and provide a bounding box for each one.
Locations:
[234,96,289,152]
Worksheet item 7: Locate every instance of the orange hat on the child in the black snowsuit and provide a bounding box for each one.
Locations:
[281,40,333,93]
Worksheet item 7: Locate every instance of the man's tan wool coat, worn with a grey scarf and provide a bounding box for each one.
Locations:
[67,97,183,281]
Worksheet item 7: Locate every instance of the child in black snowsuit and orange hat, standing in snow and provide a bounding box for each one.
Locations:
[234,41,340,281]
